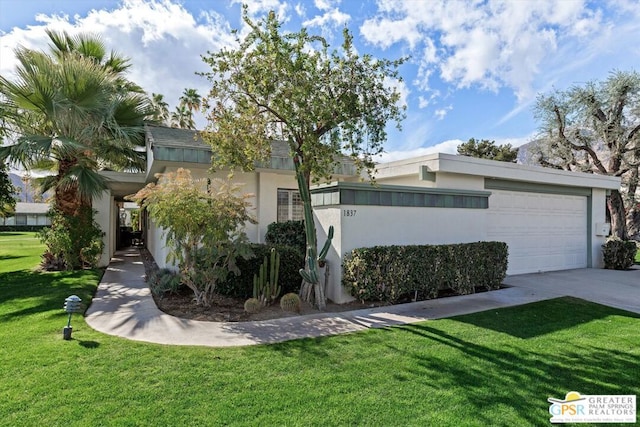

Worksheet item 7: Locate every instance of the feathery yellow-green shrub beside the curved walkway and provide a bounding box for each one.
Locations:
[128,168,255,306]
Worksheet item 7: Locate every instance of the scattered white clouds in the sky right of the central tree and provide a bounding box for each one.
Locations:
[360,0,640,101]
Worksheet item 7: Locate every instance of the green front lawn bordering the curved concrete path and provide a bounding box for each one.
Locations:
[0,236,640,426]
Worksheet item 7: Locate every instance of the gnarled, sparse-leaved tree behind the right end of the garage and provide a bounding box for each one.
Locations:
[534,71,640,239]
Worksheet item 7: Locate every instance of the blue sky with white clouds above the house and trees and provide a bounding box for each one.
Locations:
[0,0,640,160]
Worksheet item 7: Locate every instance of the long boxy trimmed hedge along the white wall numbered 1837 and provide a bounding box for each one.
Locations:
[342,242,508,303]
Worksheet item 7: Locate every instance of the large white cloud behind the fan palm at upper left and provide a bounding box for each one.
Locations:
[0,0,238,127]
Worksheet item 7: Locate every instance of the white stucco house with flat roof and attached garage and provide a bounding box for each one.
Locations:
[94,126,620,303]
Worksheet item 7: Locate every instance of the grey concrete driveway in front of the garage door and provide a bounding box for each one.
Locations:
[504,265,640,313]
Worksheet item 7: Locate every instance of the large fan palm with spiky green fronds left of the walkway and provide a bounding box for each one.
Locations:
[0,31,148,266]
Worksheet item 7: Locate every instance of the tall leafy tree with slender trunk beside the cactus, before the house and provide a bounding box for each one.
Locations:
[203,8,404,309]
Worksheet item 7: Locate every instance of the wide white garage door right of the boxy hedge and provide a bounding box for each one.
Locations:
[487,190,587,274]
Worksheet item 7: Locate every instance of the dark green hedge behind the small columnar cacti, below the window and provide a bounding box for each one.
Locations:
[216,244,304,298]
